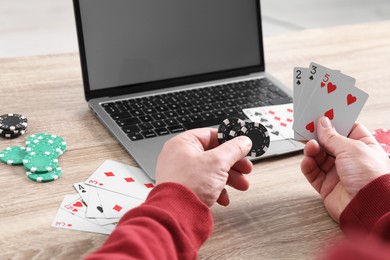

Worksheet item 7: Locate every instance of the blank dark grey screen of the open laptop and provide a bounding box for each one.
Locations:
[74,0,263,98]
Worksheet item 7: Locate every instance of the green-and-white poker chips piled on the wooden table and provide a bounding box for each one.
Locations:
[0,133,66,182]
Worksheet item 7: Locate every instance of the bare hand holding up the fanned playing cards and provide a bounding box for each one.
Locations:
[301,117,390,222]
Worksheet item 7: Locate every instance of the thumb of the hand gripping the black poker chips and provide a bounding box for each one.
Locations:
[212,136,252,166]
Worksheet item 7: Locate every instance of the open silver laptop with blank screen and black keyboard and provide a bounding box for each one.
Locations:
[73,0,303,179]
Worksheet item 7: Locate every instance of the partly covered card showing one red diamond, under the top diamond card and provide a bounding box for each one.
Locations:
[97,189,144,219]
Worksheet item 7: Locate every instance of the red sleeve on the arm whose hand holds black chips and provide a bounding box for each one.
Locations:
[86,183,213,259]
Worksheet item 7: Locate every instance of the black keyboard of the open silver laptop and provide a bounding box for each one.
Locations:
[101,78,292,141]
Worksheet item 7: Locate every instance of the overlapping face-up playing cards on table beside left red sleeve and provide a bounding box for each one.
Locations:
[52,160,155,234]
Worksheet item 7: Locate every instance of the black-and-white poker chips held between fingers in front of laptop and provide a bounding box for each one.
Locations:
[218,117,270,157]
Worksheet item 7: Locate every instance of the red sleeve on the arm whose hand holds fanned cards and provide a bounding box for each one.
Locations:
[327,174,390,260]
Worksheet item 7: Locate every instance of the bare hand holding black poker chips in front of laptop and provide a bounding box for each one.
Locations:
[156,128,252,206]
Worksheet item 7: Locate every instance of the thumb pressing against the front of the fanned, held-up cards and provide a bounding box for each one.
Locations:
[317,117,349,156]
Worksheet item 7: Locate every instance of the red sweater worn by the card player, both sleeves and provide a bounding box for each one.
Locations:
[86,174,390,260]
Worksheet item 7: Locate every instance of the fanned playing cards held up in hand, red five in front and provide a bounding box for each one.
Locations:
[293,63,368,140]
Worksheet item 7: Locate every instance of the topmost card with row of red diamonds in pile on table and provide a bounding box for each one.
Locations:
[85,160,155,200]
